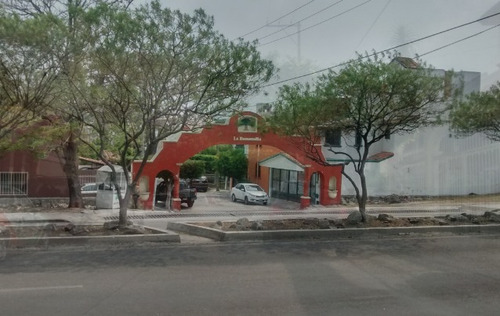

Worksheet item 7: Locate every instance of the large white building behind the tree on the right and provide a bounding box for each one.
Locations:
[323,58,500,196]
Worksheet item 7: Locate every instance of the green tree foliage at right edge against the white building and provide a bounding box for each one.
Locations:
[450,81,500,142]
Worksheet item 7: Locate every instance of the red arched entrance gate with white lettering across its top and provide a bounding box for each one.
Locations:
[132,112,342,210]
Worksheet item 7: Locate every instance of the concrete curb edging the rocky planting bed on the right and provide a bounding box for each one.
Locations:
[167,222,500,241]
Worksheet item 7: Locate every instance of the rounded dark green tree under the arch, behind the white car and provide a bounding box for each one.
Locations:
[216,148,248,181]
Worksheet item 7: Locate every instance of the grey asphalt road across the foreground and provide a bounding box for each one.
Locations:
[0,236,500,316]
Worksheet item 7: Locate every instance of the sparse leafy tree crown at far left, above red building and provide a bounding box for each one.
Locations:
[0,11,61,155]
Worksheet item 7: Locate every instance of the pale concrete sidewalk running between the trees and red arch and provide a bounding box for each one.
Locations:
[0,202,500,225]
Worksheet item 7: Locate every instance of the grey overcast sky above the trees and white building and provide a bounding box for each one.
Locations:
[160,0,500,95]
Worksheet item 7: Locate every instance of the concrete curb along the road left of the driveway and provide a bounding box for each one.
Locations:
[0,226,180,249]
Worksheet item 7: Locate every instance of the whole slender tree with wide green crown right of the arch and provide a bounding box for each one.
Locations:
[268,56,443,220]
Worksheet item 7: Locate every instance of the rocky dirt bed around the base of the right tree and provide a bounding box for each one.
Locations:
[196,212,500,231]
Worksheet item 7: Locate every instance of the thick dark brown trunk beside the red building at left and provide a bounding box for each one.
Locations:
[62,132,83,208]
